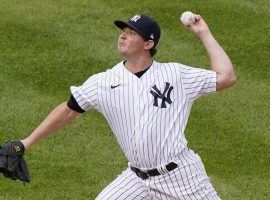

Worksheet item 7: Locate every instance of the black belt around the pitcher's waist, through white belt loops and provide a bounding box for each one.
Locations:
[130,162,178,180]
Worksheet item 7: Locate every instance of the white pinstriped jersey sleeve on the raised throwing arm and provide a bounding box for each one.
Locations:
[181,65,217,100]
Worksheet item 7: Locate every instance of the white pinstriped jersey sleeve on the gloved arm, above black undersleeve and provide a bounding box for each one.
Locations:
[70,73,102,111]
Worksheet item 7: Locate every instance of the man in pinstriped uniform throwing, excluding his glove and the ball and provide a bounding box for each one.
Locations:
[11,11,236,200]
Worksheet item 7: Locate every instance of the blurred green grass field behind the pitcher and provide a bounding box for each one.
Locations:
[0,0,270,200]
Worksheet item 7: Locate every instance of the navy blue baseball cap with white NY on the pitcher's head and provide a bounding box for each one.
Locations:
[114,14,160,47]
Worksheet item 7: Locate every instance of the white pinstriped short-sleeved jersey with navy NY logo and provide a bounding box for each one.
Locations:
[71,61,217,169]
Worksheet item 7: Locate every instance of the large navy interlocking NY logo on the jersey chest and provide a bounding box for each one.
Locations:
[150,82,173,108]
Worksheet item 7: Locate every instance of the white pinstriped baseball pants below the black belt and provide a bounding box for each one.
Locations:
[96,150,220,200]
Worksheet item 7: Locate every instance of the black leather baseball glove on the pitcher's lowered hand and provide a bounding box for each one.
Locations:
[0,141,30,183]
